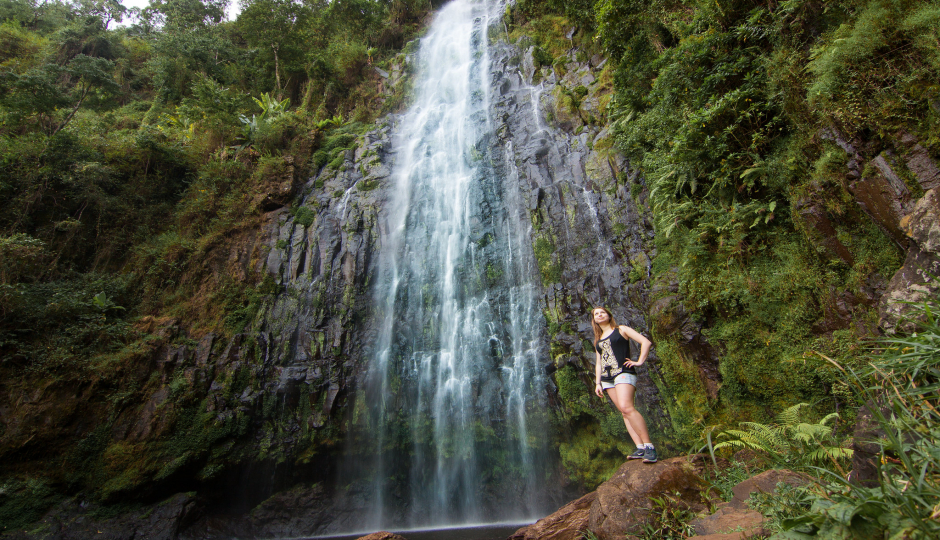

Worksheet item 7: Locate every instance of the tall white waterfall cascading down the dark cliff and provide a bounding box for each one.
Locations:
[344,0,552,527]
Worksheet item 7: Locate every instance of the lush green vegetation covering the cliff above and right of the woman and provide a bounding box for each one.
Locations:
[507,0,940,468]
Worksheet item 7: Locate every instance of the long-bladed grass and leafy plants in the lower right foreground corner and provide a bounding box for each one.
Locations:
[713,304,940,540]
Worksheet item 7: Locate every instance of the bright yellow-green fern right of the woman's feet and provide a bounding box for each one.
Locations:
[715,403,852,470]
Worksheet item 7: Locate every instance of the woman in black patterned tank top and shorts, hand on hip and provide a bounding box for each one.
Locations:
[591,307,657,463]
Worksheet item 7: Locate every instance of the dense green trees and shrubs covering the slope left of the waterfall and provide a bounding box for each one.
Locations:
[0,0,435,527]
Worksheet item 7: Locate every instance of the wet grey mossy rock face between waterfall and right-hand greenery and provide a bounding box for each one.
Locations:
[491,38,672,442]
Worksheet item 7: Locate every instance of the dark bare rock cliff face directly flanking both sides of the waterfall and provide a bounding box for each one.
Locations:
[4,21,669,536]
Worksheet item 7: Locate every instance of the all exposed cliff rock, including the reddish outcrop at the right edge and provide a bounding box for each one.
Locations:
[0,9,940,537]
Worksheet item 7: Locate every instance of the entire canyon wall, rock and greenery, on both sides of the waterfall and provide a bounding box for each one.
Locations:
[0,1,940,537]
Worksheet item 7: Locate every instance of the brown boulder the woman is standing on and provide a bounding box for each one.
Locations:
[587,457,705,540]
